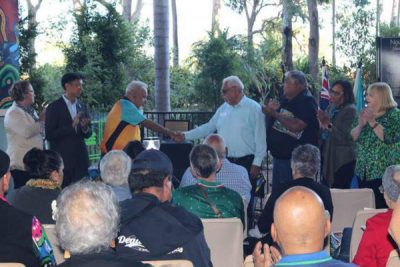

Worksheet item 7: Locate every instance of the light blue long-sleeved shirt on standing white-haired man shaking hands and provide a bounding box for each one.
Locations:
[185,96,267,166]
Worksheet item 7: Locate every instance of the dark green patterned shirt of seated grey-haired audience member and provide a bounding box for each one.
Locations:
[172,180,244,225]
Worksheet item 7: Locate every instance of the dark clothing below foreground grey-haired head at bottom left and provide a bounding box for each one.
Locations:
[58,251,150,267]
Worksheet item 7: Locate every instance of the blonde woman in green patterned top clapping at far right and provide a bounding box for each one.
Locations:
[351,82,400,208]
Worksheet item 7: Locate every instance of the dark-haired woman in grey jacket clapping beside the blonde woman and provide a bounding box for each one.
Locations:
[318,80,356,188]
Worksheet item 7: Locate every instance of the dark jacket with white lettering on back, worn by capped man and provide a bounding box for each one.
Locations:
[116,193,212,267]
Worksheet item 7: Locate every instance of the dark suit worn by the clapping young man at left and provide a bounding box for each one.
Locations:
[45,97,92,187]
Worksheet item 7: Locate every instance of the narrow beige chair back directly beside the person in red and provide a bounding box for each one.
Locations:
[349,209,387,262]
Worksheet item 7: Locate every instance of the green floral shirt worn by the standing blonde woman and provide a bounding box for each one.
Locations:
[353,108,400,180]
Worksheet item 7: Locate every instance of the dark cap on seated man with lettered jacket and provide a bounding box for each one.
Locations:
[132,149,173,175]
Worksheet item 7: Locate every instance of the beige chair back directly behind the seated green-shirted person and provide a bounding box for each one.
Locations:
[201,218,243,267]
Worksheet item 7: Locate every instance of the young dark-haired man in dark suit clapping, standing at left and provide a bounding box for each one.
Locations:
[45,73,92,187]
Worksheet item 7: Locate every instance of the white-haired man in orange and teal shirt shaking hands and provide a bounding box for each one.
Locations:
[100,81,176,154]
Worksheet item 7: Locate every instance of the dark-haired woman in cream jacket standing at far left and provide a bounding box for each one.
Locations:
[4,81,45,188]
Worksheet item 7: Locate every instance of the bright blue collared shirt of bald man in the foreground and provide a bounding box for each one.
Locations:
[274,250,356,267]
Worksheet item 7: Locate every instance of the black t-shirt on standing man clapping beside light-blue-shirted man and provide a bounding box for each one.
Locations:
[267,90,319,159]
